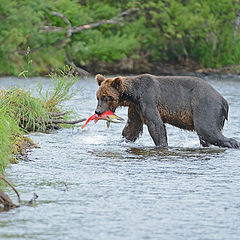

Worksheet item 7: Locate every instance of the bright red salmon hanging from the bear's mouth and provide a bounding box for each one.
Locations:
[81,111,124,129]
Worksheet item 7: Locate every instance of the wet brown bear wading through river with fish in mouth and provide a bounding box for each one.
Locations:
[95,74,240,148]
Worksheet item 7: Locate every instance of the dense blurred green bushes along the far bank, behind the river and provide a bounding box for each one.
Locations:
[0,0,240,75]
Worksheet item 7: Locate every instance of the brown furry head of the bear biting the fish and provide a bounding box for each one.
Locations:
[95,74,125,115]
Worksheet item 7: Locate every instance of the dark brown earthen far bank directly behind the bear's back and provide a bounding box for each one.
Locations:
[84,58,240,76]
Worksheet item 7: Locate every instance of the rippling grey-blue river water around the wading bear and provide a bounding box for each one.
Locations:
[0,74,240,240]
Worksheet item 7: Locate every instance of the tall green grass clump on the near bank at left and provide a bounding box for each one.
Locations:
[0,67,77,174]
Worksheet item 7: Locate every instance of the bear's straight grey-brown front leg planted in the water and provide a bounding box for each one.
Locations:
[143,106,168,147]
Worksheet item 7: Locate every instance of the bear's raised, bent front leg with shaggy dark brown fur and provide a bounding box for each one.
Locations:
[122,104,143,142]
